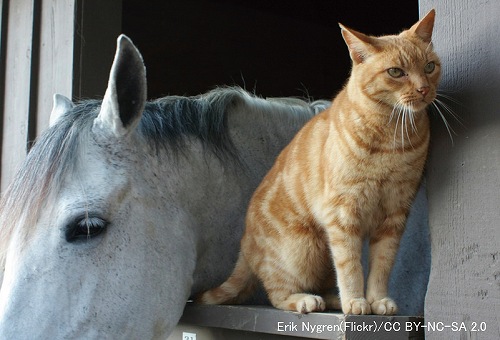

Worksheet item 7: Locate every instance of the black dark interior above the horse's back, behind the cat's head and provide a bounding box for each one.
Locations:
[122,0,418,99]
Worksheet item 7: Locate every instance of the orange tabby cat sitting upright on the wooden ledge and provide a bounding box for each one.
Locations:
[198,10,440,314]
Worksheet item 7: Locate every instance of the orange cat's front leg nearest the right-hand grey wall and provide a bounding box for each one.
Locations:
[366,210,406,315]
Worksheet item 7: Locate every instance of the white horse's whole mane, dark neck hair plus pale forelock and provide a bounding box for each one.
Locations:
[0,88,325,268]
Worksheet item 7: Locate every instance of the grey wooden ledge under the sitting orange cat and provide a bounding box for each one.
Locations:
[169,303,425,340]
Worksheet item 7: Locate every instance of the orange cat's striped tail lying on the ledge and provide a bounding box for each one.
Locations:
[195,252,258,305]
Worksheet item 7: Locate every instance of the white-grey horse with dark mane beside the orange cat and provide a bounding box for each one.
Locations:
[0,35,426,339]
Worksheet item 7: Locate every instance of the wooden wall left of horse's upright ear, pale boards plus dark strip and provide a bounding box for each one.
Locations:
[0,0,121,191]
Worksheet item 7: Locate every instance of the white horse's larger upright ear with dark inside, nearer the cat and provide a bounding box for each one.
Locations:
[94,34,147,137]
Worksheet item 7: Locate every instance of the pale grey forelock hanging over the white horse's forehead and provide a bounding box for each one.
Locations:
[0,101,98,268]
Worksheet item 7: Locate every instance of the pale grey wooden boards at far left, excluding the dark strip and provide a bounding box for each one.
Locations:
[0,0,75,190]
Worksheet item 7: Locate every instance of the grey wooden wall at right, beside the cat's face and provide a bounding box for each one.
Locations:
[420,0,500,339]
